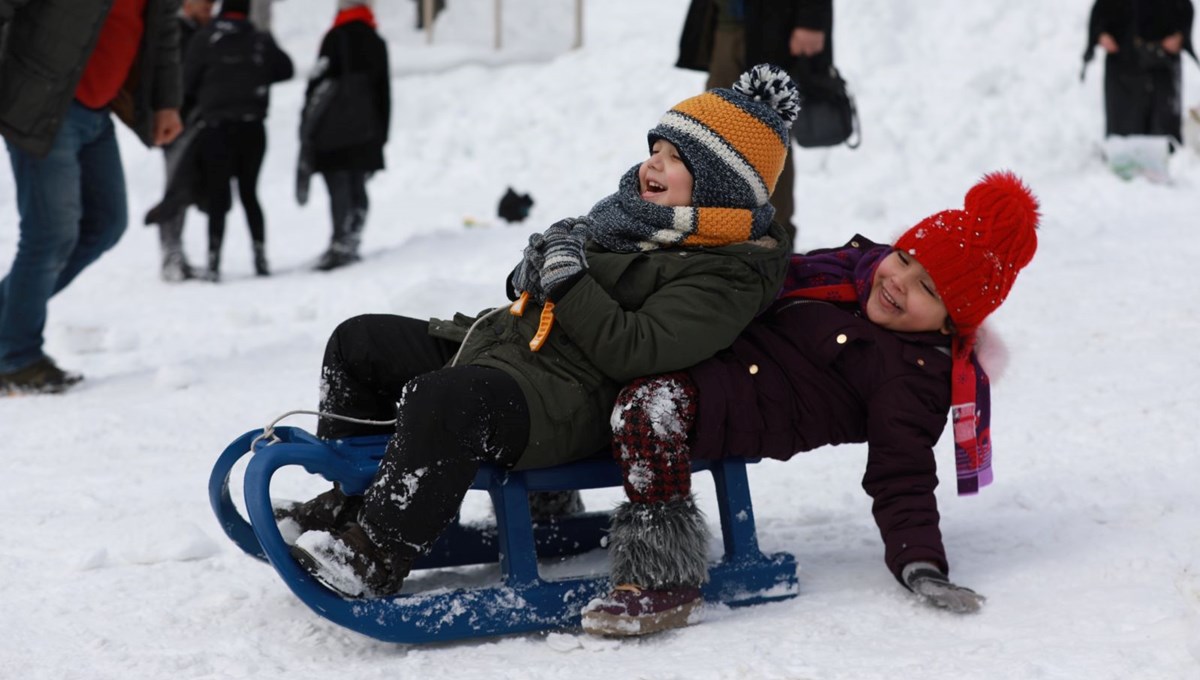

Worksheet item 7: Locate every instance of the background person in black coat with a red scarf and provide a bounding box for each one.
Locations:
[300,0,391,271]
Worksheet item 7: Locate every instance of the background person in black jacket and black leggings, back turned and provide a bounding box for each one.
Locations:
[184,0,293,281]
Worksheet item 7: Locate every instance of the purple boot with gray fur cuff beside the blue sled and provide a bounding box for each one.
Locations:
[583,495,708,637]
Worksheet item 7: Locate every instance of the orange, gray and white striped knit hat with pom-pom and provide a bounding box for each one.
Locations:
[648,64,799,214]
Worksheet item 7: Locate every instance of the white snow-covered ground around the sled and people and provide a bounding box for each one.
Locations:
[0,0,1200,680]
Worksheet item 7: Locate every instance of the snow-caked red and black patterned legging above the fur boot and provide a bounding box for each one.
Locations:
[612,372,696,504]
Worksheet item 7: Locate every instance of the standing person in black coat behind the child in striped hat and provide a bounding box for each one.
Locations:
[676,0,833,242]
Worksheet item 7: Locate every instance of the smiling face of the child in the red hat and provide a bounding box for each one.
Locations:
[866,251,950,333]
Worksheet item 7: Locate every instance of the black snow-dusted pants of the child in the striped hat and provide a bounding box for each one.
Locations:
[317,314,529,558]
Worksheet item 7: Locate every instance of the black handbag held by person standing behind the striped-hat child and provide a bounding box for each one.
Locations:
[792,66,863,149]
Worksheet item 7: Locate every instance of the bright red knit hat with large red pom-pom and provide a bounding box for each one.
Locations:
[895,170,1038,336]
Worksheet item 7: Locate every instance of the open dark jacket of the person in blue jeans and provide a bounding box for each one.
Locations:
[0,0,184,156]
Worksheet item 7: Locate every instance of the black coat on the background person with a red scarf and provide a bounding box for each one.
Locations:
[305,20,391,173]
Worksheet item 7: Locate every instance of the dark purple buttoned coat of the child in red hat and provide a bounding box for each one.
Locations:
[691,236,950,578]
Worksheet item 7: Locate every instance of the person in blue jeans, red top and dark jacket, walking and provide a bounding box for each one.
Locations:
[0,0,182,396]
